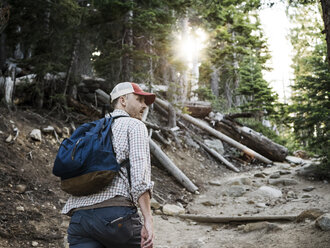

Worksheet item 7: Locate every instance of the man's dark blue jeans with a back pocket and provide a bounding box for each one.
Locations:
[68,207,142,248]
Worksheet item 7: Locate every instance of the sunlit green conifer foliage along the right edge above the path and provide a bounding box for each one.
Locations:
[287,3,330,171]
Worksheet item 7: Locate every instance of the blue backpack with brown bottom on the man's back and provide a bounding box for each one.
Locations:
[53,116,130,196]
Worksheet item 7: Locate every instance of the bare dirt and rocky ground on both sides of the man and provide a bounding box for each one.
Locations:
[0,108,330,248]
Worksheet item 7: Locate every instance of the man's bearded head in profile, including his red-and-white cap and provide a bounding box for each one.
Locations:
[110,82,156,119]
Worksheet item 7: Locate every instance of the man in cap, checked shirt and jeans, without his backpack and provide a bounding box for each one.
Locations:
[62,82,155,248]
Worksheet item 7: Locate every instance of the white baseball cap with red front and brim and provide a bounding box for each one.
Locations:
[110,82,156,105]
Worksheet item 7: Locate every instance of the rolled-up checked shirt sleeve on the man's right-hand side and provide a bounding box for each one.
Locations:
[128,121,153,204]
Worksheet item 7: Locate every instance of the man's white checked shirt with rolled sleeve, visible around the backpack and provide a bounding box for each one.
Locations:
[62,109,153,214]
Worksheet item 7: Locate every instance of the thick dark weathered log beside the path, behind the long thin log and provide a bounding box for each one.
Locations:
[216,118,288,162]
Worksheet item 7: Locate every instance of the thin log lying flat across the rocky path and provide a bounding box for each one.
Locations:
[178,214,297,223]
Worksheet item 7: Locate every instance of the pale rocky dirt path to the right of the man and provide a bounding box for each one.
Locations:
[154,161,330,248]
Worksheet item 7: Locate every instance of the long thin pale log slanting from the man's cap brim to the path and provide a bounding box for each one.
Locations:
[156,98,273,164]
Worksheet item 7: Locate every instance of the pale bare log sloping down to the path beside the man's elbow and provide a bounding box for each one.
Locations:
[149,139,198,193]
